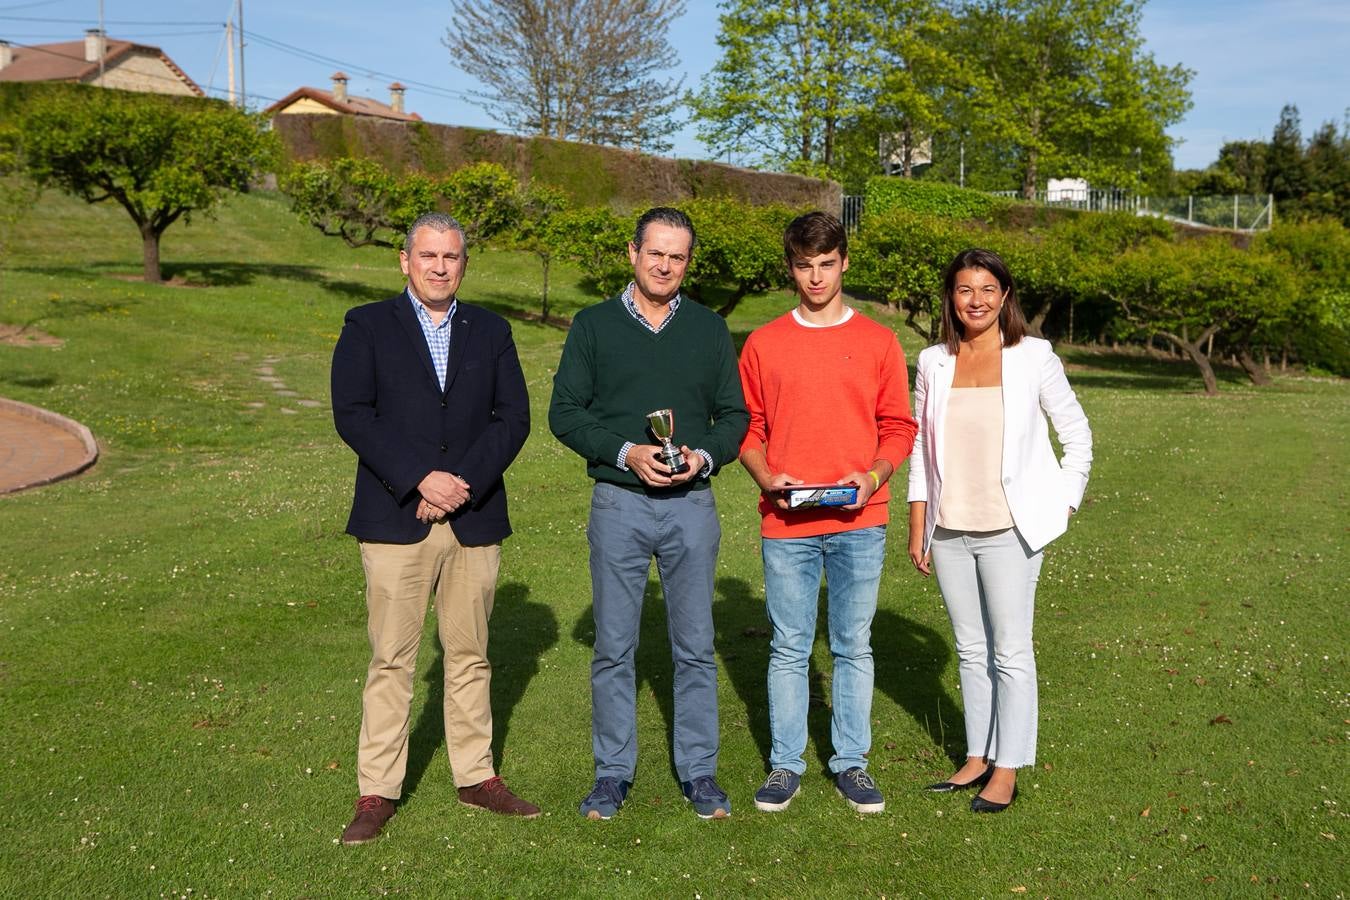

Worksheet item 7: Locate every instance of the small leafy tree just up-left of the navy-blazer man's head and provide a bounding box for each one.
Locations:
[281,157,436,248]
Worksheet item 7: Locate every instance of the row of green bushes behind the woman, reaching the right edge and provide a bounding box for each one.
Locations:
[848,206,1350,383]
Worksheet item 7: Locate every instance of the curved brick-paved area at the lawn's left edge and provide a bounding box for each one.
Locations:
[0,397,99,494]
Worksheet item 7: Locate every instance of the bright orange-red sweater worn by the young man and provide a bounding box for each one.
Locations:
[740,312,915,537]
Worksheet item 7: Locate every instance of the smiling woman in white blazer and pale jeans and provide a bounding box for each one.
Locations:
[909,250,1092,812]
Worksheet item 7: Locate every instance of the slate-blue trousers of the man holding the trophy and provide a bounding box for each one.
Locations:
[586,482,722,781]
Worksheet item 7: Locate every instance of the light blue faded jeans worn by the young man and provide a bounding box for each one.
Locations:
[763,525,886,775]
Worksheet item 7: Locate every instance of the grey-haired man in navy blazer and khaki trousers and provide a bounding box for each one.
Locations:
[332,213,539,843]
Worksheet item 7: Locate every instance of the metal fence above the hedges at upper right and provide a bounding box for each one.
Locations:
[842,189,1274,232]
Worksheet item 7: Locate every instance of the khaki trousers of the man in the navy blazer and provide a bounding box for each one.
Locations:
[356,522,501,800]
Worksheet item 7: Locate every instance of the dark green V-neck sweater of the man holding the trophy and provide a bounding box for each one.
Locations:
[548,298,749,488]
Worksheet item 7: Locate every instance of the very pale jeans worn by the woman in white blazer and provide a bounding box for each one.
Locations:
[932,528,1041,769]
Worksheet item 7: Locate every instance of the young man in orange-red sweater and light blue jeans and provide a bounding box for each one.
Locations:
[740,212,915,812]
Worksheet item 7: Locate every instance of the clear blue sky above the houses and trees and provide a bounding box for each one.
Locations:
[0,0,1350,169]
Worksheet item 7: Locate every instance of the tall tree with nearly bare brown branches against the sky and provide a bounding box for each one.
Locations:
[443,0,684,152]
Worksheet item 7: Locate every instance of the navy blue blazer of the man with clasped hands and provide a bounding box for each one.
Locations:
[332,291,529,545]
